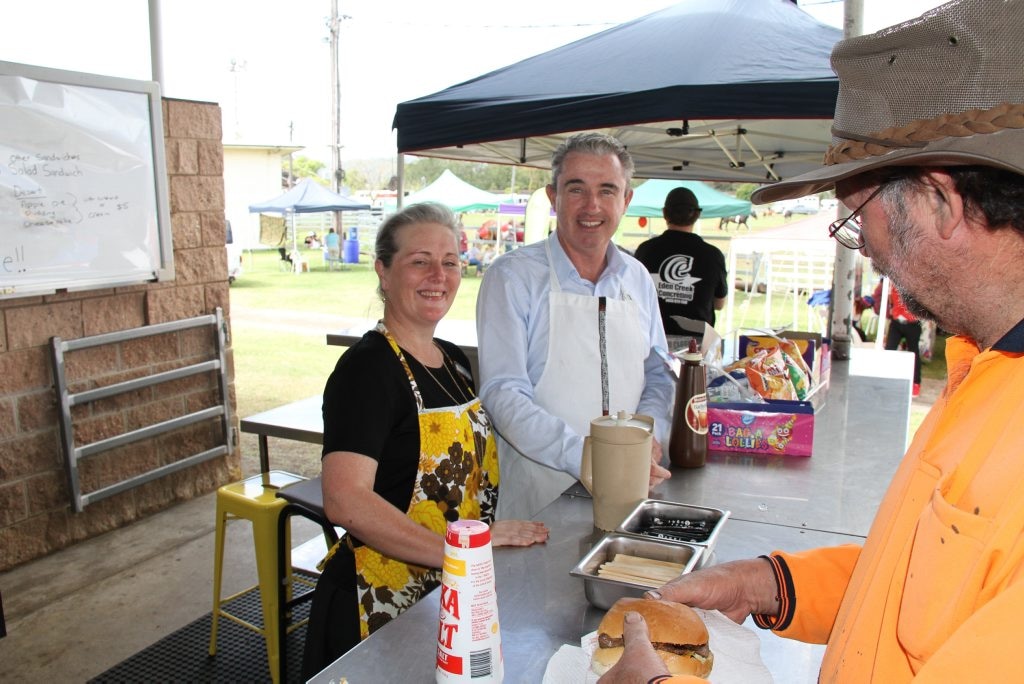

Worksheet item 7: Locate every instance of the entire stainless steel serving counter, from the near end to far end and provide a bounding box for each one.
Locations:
[312,349,913,684]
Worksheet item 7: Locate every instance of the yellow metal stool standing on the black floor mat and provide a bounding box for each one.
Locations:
[210,470,305,684]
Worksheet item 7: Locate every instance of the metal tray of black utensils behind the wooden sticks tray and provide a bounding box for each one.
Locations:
[615,499,729,558]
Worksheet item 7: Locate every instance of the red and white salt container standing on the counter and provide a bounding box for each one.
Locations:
[435,520,504,682]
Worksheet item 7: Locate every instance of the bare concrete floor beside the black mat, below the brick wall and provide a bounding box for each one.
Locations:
[0,494,323,682]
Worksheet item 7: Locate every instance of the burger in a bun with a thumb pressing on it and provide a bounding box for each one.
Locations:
[591,598,714,684]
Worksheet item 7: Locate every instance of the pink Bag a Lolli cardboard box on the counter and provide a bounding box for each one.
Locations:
[708,399,814,456]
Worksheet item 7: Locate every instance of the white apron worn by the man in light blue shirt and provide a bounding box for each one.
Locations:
[498,244,648,520]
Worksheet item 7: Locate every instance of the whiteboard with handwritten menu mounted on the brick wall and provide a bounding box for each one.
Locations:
[0,61,174,298]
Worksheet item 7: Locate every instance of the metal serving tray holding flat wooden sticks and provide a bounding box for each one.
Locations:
[569,532,703,610]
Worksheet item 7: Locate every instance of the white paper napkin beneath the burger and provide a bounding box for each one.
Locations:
[544,608,772,684]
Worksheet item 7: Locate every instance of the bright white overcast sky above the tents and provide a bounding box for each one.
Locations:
[0,0,940,161]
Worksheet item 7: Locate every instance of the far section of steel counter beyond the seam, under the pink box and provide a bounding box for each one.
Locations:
[569,348,913,537]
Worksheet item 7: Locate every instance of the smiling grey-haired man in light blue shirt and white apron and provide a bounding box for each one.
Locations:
[476,133,675,519]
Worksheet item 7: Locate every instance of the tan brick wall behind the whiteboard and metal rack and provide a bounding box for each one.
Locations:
[0,99,241,571]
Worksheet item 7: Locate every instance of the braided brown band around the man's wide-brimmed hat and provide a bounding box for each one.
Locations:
[824,102,1024,166]
